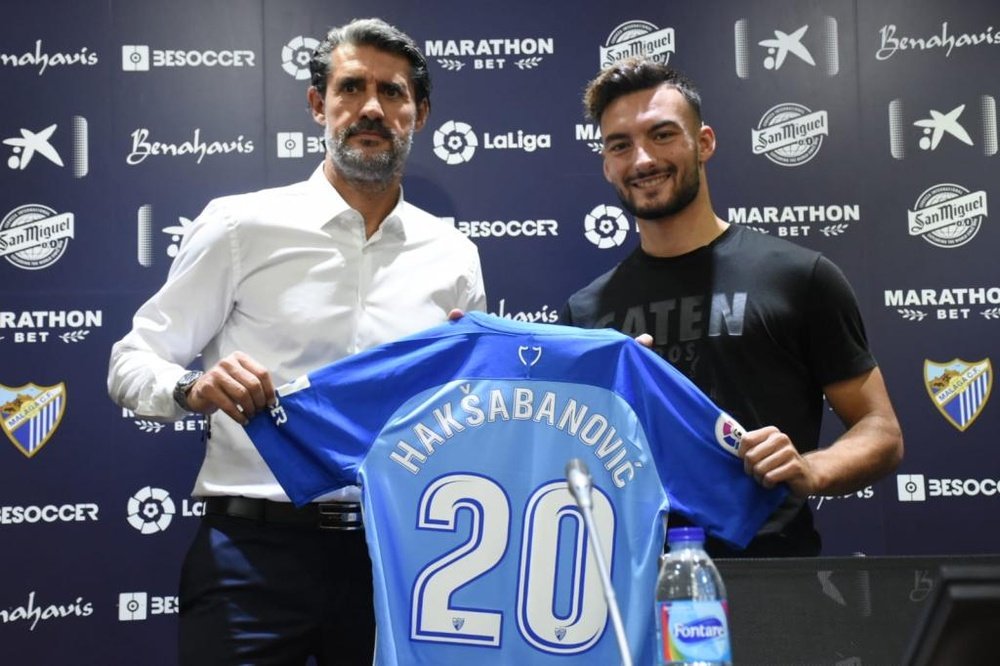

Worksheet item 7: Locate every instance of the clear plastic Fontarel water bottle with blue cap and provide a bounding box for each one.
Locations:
[656,527,733,666]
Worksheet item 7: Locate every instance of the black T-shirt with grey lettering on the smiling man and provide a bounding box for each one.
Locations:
[560,226,875,550]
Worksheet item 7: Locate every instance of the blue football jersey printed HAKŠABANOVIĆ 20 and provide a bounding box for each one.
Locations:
[247,313,786,666]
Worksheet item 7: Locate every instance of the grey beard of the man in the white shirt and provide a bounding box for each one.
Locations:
[323,118,413,189]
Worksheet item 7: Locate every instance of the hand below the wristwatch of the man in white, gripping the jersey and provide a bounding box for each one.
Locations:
[187,352,274,425]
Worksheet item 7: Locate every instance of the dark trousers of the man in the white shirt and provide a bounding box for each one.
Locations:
[179,515,375,666]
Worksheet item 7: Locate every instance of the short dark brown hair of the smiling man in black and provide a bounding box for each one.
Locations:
[583,56,701,123]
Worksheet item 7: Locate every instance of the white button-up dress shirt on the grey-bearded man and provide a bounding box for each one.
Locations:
[108,166,486,501]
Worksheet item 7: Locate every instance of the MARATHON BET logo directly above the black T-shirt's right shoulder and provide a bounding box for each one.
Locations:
[729,204,861,238]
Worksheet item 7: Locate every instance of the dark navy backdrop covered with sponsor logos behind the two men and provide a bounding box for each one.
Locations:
[0,0,1000,664]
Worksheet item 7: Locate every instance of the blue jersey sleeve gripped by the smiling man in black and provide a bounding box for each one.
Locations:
[623,343,788,548]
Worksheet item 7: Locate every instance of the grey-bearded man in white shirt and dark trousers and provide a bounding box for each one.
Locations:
[108,19,486,664]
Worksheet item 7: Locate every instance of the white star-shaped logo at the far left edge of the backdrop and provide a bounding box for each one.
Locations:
[3,116,90,178]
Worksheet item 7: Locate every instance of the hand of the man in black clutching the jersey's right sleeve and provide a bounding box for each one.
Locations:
[738,426,818,497]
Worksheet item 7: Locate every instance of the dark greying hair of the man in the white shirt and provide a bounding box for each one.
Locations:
[309,18,431,106]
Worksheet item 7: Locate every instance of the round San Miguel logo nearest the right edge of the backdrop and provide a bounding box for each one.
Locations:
[907,183,988,248]
